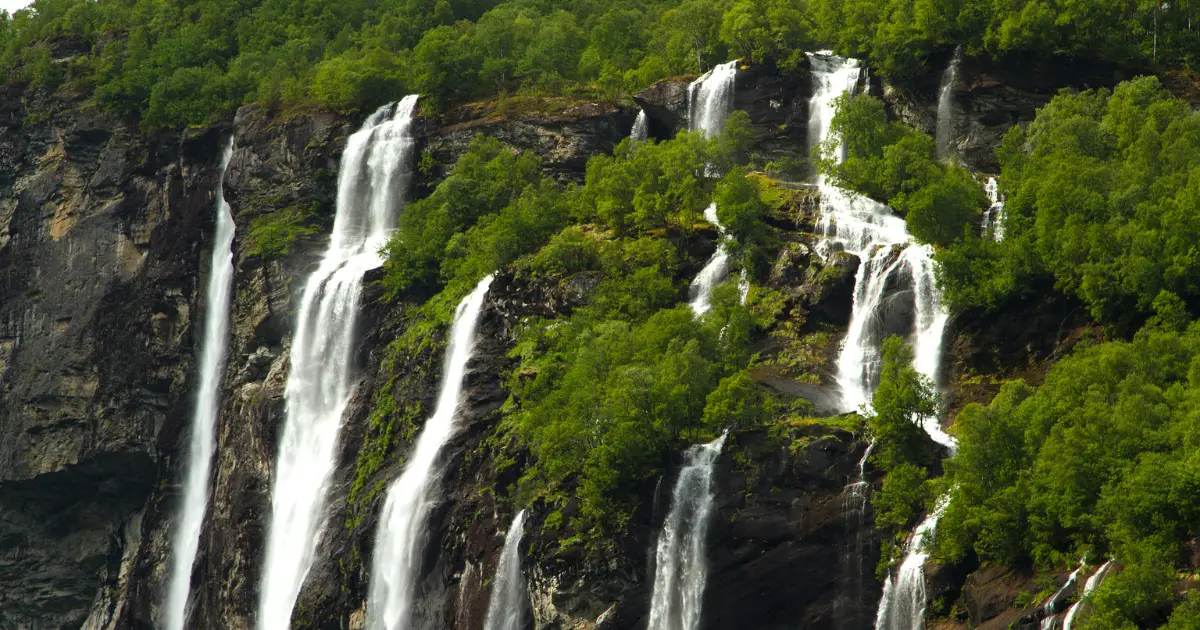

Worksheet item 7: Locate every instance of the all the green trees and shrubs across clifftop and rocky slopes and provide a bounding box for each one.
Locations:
[0,0,1200,630]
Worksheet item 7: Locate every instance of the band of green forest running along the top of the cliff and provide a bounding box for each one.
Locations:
[0,0,1200,128]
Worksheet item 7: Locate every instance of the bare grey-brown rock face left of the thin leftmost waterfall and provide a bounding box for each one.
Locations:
[0,89,221,628]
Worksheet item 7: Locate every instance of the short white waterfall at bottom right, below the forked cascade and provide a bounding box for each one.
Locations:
[875,496,949,630]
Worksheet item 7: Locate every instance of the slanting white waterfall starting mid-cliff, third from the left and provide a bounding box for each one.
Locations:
[367,276,492,630]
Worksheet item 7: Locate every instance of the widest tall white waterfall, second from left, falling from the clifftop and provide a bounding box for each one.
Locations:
[258,96,416,630]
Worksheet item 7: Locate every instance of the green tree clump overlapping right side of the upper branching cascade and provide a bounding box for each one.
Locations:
[817,95,988,245]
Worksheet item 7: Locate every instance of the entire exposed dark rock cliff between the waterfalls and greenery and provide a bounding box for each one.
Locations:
[0,57,1080,630]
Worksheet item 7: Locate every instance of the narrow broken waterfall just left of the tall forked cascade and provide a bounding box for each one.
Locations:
[691,59,734,316]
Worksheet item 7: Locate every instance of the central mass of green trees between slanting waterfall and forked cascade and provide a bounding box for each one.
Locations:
[369,119,775,532]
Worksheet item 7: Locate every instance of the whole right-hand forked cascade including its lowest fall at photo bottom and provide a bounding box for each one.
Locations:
[809,53,955,630]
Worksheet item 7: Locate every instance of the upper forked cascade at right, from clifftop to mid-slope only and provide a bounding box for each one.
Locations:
[809,53,954,449]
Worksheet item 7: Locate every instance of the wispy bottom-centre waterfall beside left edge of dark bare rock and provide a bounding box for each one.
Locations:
[647,434,726,630]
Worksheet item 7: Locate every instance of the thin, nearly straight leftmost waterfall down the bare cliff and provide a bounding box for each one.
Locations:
[163,137,234,630]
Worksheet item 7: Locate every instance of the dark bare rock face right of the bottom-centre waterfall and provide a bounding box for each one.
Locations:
[703,425,881,630]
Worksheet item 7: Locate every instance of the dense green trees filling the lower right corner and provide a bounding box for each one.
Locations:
[936,325,1200,628]
